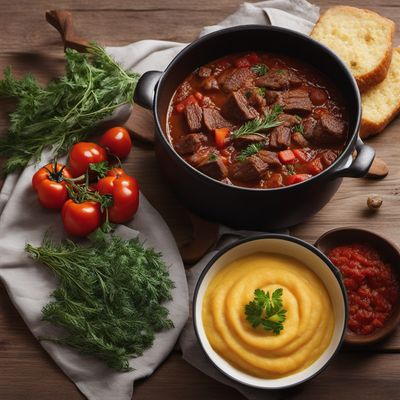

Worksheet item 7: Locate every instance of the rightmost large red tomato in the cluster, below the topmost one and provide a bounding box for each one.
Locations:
[97,175,139,224]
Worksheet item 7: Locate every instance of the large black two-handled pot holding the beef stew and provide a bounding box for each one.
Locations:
[135,25,375,230]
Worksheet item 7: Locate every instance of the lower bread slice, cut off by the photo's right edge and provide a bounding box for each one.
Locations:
[360,47,400,138]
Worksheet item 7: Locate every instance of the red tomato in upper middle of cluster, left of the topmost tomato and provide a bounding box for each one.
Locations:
[69,142,107,177]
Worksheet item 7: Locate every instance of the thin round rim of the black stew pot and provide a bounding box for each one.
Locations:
[152,24,361,193]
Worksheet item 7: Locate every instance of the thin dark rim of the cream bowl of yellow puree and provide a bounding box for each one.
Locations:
[192,233,349,391]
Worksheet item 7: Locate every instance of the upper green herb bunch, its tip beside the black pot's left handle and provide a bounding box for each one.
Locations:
[0,43,139,174]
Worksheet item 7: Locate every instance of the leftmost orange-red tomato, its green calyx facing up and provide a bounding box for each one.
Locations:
[32,164,72,209]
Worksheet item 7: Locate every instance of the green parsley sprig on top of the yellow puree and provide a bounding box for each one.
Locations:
[245,288,287,335]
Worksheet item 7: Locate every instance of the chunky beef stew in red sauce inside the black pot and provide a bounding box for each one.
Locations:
[167,52,348,189]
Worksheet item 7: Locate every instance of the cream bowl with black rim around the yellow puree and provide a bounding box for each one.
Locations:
[193,234,347,389]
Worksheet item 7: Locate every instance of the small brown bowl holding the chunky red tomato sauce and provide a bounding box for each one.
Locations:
[315,227,400,346]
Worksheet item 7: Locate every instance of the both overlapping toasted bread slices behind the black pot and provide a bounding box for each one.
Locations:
[311,6,400,137]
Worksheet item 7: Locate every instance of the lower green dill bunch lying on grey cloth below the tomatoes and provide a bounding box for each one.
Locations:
[26,231,174,371]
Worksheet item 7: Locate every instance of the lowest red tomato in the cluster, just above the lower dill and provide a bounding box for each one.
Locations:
[61,199,102,237]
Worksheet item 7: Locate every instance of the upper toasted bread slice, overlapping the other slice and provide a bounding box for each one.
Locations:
[311,6,395,92]
